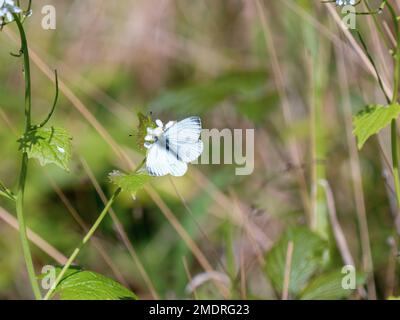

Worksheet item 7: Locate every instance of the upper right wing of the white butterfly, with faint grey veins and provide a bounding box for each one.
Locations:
[164,117,204,163]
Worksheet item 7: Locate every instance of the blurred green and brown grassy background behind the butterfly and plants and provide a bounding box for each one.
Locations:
[0,0,399,299]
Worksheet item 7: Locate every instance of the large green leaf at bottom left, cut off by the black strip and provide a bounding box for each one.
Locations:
[54,268,137,300]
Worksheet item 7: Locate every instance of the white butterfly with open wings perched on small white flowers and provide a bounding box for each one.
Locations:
[144,117,203,177]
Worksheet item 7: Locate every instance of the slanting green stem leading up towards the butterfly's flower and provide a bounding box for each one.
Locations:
[44,188,121,300]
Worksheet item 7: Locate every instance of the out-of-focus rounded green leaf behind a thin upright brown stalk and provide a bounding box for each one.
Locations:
[265,228,326,296]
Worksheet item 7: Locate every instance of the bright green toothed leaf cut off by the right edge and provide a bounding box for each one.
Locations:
[353,103,400,149]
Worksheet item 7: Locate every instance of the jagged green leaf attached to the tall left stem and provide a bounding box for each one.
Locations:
[18,127,72,171]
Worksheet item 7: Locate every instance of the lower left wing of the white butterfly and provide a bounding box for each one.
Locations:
[146,140,187,177]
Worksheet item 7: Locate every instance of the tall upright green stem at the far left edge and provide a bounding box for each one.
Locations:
[14,14,42,300]
